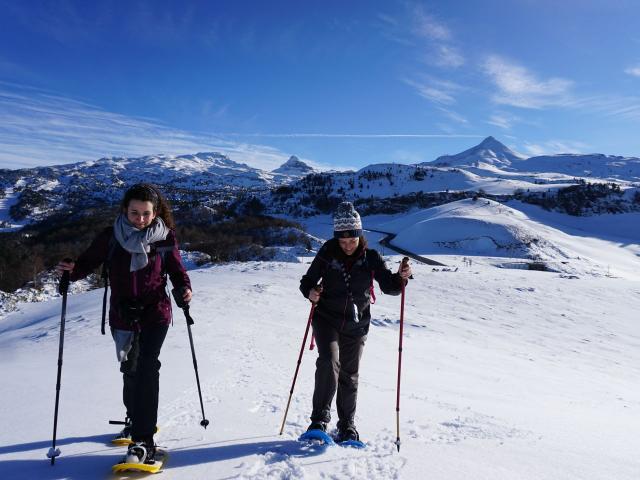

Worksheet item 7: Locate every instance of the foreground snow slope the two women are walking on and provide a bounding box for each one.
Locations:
[0,248,640,480]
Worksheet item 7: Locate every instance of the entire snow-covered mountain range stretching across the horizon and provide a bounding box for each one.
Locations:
[0,137,640,229]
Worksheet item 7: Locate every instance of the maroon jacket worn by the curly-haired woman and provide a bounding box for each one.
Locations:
[69,227,191,330]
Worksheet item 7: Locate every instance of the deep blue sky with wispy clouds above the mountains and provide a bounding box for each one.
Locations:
[0,0,640,169]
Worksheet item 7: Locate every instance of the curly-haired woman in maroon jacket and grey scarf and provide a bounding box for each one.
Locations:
[57,183,192,464]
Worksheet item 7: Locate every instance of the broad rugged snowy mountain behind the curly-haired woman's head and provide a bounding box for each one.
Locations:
[0,152,302,224]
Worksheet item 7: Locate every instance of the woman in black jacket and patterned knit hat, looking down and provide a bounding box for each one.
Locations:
[300,202,411,441]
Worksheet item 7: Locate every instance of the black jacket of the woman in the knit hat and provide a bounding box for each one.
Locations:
[300,239,402,337]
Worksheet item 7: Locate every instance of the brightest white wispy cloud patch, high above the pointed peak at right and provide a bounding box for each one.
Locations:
[483,55,574,108]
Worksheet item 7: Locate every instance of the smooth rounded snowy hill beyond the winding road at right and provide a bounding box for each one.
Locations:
[370,198,640,280]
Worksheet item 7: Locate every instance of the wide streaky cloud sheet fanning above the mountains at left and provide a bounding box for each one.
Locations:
[0,82,302,170]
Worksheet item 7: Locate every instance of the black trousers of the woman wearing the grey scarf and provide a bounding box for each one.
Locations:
[120,325,169,441]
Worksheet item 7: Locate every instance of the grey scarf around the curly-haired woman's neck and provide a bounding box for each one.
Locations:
[113,214,169,272]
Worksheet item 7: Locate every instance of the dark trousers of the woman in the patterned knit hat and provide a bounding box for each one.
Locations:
[311,321,367,428]
